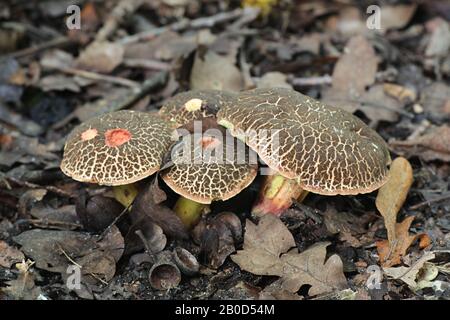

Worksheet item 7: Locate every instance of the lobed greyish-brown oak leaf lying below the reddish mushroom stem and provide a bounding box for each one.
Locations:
[231,215,347,295]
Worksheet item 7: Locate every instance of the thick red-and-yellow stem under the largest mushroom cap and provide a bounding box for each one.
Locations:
[252,174,308,216]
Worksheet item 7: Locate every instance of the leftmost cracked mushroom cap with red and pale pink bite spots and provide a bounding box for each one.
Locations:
[61,110,173,186]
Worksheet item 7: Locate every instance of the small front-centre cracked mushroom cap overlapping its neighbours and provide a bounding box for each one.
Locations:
[162,134,258,204]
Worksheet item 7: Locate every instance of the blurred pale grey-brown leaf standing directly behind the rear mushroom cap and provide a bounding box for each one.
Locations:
[190,50,244,92]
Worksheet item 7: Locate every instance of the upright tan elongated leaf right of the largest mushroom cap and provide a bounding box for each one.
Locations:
[375,157,413,244]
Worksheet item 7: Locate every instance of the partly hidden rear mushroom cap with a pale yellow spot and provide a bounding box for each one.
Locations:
[159,90,236,128]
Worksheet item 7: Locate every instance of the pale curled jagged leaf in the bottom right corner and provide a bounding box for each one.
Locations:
[383,252,437,290]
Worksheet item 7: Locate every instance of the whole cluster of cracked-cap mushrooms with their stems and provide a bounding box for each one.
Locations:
[61,88,391,227]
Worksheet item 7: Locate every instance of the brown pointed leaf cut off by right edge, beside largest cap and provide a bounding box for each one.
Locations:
[390,125,450,162]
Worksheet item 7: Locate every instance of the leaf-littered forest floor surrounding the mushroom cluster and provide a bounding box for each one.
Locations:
[0,0,450,300]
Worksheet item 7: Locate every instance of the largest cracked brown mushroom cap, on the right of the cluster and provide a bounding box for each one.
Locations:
[217,88,391,195]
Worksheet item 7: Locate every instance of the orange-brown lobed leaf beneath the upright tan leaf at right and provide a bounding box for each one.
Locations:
[376,216,431,267]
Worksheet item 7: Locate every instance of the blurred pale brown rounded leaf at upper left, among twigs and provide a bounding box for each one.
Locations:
[76,41,125,73]
